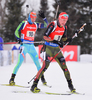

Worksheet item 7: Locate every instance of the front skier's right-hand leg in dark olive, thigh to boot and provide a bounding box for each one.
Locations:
[56,54,75,92]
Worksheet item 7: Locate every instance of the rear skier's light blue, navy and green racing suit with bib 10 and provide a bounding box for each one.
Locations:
[13,18,48,74]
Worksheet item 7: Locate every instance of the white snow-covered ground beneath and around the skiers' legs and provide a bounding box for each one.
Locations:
[0,55,92,100]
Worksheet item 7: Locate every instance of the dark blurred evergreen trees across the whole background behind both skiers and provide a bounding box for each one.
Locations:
[0,0,92,54]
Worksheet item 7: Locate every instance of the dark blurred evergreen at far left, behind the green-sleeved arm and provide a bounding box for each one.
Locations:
[1,0,25,42]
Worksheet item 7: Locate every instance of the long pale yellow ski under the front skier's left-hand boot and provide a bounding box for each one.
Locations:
[12,91,71,95]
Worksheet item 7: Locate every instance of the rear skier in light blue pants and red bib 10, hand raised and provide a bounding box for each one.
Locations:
[9,12,48,85]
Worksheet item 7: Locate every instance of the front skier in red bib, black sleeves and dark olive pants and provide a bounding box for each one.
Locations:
[30,12,75,93]
